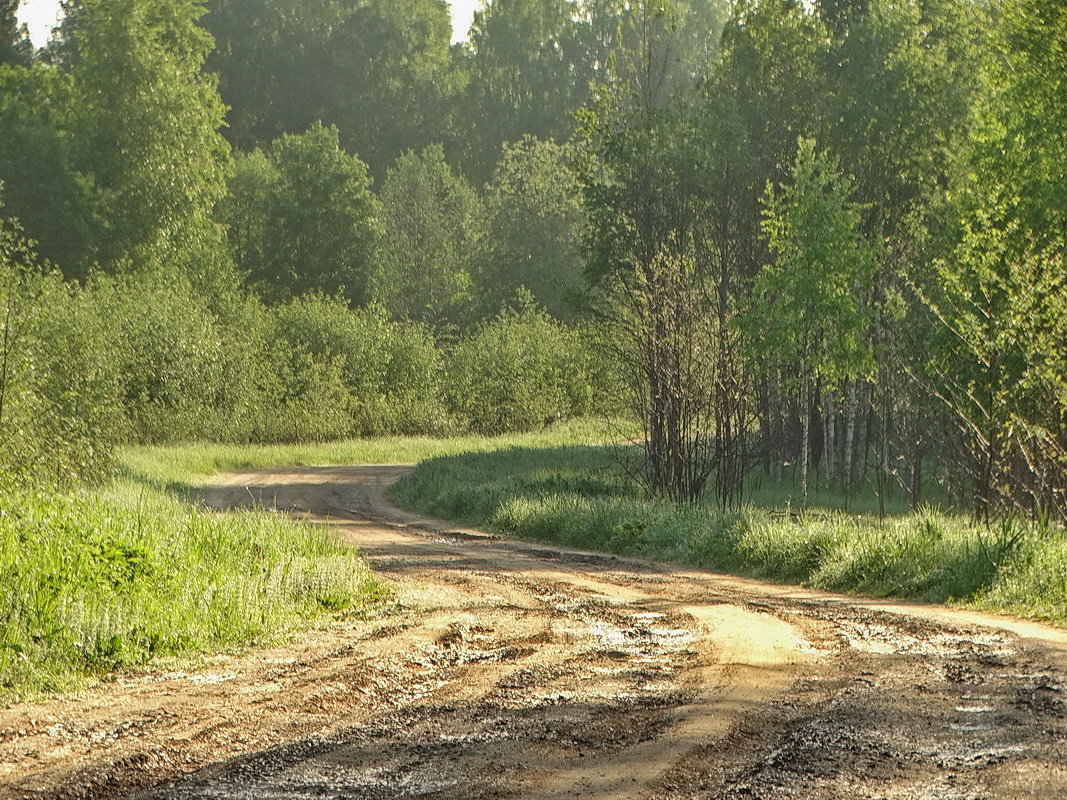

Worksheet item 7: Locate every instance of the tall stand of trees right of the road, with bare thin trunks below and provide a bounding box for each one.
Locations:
[584,0,1067,519]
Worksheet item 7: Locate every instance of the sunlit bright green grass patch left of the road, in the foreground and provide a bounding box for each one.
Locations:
[0,481,385,699]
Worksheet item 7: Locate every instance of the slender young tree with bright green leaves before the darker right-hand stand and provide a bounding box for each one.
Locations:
[748,139,876,506]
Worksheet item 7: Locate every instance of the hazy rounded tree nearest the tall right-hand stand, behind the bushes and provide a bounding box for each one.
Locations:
[478,137,585,318]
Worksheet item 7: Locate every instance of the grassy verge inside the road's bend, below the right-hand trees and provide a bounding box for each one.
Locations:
[393,447,1067,623]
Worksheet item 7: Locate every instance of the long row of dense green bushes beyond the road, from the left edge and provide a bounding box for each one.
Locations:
[0,224,598,483]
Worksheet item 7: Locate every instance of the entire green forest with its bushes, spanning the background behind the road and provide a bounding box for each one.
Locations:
[0,0,1067,695]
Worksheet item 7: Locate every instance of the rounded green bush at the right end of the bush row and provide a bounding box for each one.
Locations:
[447,306,595,434]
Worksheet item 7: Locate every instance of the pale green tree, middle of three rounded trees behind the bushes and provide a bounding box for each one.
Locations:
[373,145,484,332]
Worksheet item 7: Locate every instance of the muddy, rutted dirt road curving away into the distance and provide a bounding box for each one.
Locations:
[0,467,1067,800]
